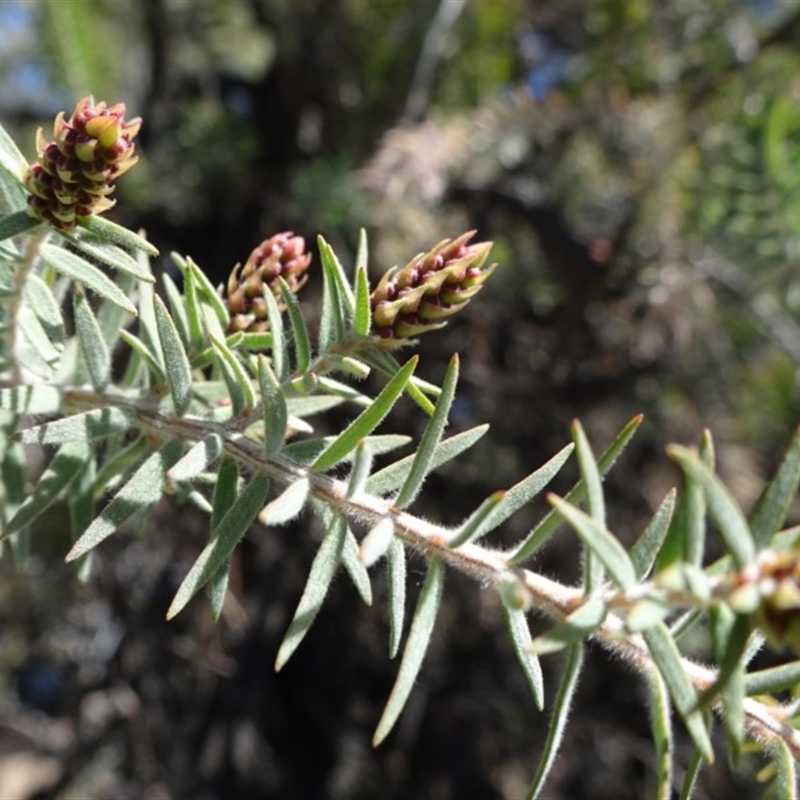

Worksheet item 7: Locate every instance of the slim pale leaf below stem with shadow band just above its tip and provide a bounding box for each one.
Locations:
[275,514,347,672]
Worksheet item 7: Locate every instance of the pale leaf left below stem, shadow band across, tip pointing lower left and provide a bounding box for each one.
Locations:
[66,440,181,561]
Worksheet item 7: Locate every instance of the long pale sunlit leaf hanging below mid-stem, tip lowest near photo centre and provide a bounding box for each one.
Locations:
[372,559,445,747]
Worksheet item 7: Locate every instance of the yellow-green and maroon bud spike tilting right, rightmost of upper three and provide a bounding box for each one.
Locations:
[370,231,497,347]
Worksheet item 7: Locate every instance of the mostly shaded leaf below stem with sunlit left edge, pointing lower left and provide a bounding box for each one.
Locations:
[167,475,269,619]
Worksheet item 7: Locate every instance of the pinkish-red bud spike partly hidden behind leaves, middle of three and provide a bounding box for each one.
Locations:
[225,231,311,333]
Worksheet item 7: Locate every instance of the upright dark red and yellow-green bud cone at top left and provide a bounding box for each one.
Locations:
[25,97,141,230]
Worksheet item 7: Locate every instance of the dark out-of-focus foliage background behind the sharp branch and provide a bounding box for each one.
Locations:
[0,0,800,798]
